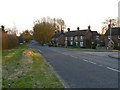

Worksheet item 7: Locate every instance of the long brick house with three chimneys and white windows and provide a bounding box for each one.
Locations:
[65,26,99,48]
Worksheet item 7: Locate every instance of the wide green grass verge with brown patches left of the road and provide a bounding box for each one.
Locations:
[2,45,64,88]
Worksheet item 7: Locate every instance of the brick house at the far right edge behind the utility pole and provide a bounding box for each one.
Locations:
[105,27,120,50]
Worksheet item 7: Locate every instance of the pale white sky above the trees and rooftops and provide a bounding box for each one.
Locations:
[0,0,120,32]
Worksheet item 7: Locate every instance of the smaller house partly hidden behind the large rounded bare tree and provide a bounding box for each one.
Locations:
[51,30,65,46]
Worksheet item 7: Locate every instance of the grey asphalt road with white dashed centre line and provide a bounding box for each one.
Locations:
[30,42,120,88]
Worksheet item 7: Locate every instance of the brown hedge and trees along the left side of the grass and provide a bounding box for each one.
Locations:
[0,26,32,50]
